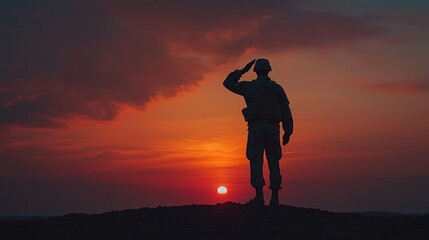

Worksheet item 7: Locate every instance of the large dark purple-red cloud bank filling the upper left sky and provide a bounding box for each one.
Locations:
[0,0,394,128]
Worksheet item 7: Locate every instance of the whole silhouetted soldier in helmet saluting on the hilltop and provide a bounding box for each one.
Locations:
[223,58,293,206]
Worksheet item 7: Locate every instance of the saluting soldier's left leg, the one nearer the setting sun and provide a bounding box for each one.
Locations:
[246,132,265,204]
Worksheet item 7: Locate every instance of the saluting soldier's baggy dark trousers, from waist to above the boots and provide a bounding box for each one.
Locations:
[246,132,282,189]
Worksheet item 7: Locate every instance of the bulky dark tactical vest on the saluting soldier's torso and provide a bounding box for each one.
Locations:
[242,80,281,122]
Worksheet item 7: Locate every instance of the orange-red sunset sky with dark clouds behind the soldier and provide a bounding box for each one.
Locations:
[0,0,429,215]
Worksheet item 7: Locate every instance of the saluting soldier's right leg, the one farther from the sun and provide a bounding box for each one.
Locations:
[265,134,282,206]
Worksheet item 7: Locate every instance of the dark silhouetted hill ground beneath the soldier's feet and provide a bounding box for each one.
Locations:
[0,202,429,240]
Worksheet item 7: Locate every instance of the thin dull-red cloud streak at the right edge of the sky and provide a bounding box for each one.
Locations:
[369,81,429,94]
